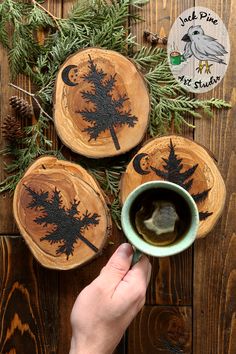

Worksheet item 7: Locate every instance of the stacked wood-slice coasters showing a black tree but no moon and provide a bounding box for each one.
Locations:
[13,156,111,269]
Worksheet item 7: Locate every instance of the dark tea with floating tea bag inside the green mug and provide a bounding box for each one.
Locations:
[130,188,191,246]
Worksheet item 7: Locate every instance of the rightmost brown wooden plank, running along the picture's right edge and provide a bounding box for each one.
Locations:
[193,0,236,354]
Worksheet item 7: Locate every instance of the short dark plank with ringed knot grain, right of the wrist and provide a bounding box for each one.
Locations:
[128,306,192,354]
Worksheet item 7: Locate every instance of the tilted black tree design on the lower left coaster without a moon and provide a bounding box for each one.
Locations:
[24,185,100,259]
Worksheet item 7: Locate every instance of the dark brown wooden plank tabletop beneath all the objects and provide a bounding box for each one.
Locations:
[0,0,236,354]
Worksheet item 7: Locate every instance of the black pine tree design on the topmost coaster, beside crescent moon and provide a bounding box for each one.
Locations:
[76,55,137,150]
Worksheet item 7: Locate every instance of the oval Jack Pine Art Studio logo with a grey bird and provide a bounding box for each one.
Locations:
[167,7,230,93]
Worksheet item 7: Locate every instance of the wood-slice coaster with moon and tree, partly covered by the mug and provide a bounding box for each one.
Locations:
[120,135,226,238]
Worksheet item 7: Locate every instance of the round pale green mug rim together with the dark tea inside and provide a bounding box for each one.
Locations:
[121,181,199,257]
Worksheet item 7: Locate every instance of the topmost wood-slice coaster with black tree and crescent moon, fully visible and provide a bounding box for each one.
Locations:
[54,48,150,158]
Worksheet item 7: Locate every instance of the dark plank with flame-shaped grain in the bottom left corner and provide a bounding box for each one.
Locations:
[0,236,59,354]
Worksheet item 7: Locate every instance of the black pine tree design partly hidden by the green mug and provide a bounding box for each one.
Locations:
[151,139,212,220]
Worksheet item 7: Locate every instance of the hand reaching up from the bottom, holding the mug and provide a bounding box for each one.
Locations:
[70,243,151,354]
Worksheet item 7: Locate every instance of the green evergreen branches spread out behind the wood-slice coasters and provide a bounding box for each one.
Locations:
[0,0,230,227]
